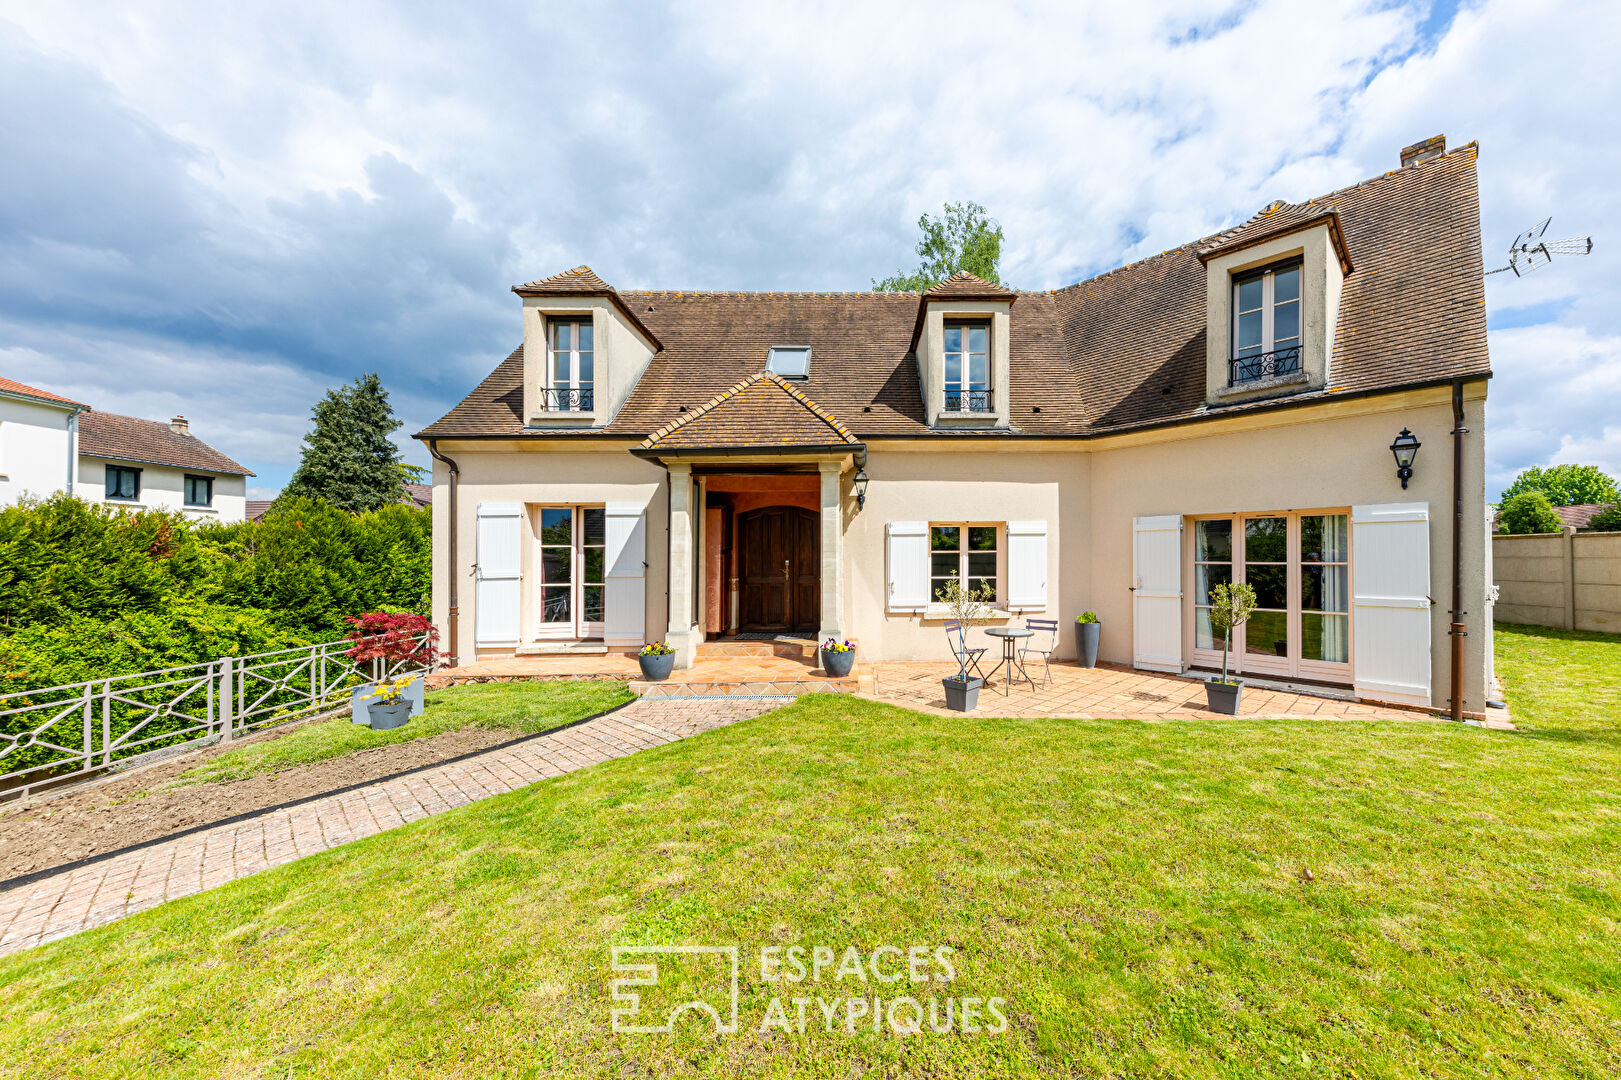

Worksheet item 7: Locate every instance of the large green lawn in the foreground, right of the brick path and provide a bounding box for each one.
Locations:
[0,629,1621,1078]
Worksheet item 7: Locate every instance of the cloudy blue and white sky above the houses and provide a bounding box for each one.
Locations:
[0,0,1621,498]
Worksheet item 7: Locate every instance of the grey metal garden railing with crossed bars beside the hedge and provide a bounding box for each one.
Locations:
[0,634,428,801]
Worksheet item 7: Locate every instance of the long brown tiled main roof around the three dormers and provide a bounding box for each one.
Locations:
[420,143,1491,439]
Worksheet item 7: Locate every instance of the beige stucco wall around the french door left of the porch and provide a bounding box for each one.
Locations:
[433,441,669,663]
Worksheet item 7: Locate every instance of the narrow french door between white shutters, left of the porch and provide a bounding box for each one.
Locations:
[533,506,608,641]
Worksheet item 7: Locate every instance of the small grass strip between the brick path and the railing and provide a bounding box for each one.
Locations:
[178,679,631,783]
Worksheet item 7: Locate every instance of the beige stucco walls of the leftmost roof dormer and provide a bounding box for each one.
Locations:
[524,297,653,426]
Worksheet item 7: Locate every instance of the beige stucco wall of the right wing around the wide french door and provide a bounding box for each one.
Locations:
[1068,383,1491,712]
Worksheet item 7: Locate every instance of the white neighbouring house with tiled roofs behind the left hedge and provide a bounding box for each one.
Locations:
[0,378,253,522]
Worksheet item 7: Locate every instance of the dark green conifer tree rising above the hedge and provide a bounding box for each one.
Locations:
[282,371,405,514]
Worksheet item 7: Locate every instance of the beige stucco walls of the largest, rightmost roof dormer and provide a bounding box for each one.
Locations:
[1204,224,1345,404]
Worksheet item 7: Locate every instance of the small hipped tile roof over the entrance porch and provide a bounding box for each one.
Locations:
[642,371,861,451]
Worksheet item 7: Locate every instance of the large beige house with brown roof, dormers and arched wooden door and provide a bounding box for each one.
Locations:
[418,138,1491,712]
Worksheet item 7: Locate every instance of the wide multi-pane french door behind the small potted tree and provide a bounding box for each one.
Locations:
[1191,509,1350,683]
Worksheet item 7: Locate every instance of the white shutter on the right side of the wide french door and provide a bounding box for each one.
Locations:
[1350,503,1431,705]
